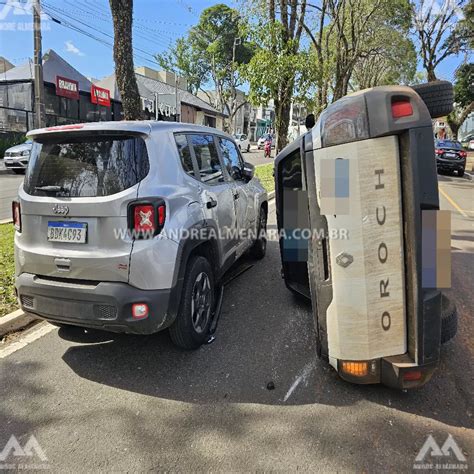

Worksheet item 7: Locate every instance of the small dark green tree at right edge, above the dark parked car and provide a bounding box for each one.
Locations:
[448,63,474,138]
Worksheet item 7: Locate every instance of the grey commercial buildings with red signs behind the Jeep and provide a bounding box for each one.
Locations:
[0,49,224,133]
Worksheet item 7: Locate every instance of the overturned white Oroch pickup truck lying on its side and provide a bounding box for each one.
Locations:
[275,82,457,388]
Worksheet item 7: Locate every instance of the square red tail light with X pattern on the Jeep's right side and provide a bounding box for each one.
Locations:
[128,199,166,239]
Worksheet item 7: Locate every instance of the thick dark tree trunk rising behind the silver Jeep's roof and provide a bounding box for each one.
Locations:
[109,0,142,120]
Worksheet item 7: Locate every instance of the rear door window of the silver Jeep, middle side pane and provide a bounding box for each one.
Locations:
[189,134,224,184]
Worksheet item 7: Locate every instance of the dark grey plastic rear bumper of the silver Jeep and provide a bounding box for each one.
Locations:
[16,273,174,334]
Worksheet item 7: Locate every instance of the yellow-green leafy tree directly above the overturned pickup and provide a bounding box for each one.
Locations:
[305,0,416,102]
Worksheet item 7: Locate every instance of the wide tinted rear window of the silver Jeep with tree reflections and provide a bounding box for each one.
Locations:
[24,135,149,197]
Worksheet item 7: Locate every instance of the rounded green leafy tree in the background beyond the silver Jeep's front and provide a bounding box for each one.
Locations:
[156,4,253,131]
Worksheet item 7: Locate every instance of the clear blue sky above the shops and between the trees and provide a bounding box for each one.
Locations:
[0,0,462,80]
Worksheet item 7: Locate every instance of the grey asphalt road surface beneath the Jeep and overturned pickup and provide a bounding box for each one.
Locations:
[0,173,474,472]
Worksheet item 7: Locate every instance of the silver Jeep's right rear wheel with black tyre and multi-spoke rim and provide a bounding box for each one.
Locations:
[169,256,214,350]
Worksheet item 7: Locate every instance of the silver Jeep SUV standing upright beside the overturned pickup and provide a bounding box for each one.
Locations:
[13,122,268,349]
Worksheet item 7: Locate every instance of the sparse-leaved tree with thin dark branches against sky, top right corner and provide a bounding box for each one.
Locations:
[413,0,472,81]
